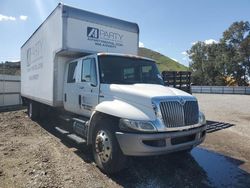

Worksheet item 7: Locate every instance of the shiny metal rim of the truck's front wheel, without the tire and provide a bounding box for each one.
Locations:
[95,130,112,162]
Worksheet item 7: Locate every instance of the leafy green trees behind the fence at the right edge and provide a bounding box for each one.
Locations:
[188,21,250,85]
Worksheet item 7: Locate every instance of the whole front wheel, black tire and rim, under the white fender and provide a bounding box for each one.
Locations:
[92,119,126,174]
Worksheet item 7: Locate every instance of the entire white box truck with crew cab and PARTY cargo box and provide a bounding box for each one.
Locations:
[21,4,206,173]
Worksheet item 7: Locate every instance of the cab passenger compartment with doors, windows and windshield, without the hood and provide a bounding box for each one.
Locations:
[64,53,164,117]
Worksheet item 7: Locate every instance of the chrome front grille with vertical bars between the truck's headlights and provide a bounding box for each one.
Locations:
[160,101,199,128]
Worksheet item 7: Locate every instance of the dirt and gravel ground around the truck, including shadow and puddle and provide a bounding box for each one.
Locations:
[0,94,250,188]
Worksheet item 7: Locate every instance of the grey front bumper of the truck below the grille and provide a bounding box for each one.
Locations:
[116,125,206,156]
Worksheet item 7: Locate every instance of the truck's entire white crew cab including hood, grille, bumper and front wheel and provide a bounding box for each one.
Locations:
[64,53,206,172]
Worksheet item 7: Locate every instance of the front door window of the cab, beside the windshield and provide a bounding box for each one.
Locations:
[81,58,97,86]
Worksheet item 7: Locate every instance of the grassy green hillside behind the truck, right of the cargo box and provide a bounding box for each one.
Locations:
[138,48,188,72]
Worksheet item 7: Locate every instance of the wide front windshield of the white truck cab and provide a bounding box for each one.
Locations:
[99,55,164,85]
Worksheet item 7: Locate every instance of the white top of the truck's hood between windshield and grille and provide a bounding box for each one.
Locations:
[101,84,193,108]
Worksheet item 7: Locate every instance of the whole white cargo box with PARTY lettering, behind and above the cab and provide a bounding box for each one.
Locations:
[21,4,139,107]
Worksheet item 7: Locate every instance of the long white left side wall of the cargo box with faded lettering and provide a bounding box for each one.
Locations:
[21,7,63,106]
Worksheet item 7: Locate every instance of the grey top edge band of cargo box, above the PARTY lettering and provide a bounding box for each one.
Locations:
[21,3,139,48]
